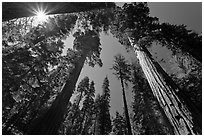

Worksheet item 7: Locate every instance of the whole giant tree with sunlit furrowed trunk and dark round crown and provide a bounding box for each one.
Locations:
[112,3,201,134]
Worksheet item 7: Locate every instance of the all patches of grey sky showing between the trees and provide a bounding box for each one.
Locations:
[65,2,202,116]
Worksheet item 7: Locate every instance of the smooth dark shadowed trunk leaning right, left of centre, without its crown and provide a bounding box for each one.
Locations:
[28,51,88,135]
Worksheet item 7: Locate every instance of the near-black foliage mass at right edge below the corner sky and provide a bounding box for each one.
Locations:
[155,23,202,62]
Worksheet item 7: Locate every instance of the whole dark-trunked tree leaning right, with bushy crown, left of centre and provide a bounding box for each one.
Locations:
[28,6,113,134]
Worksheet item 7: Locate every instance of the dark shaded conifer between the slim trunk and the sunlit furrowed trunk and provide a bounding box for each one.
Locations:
[131,62,174,135]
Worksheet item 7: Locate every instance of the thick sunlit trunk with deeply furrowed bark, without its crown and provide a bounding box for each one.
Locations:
[129,39,201,135]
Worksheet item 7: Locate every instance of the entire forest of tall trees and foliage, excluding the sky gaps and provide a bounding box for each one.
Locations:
[2,2,202,135]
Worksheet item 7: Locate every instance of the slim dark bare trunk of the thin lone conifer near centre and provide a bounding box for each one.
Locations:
[120,70,132,135]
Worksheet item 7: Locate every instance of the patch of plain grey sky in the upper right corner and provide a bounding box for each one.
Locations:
[148,2,202,33]
